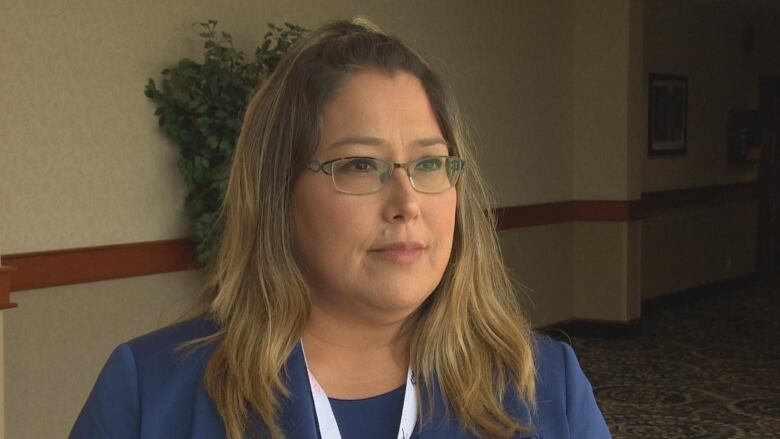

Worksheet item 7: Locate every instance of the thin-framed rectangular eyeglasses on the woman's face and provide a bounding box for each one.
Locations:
[306,156,466,195]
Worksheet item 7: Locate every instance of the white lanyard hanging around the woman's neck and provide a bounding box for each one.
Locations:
[301,342,417,439]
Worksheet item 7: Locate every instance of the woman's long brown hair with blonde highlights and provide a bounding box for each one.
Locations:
[184,19,536,439]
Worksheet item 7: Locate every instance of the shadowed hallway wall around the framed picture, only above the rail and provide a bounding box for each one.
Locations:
[642,0,780,192]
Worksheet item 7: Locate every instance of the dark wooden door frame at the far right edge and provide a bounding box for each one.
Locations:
[756,76,780,276]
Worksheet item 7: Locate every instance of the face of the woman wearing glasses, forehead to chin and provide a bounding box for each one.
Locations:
[293,69,457,323]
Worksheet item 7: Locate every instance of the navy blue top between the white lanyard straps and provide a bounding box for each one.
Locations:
[318,385,406,439]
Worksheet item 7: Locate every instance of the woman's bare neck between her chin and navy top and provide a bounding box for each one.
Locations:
[301,307,409,399]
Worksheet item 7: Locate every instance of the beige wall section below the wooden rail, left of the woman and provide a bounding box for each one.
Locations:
[3,271,198,439]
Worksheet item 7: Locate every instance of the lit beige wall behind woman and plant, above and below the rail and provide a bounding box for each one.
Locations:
[0,0,644,439]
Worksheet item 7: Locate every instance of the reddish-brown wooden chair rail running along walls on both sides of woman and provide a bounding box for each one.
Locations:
[0,183,760,294]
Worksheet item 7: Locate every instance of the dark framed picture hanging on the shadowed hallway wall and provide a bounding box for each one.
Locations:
[648,74,688,155]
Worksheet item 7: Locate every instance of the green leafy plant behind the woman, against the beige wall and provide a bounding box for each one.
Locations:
[144,20,305,263]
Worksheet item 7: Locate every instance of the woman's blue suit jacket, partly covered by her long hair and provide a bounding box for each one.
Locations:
[69,318,610,439]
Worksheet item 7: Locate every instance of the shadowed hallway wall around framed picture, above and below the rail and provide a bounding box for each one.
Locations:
[642,0,780,298]
